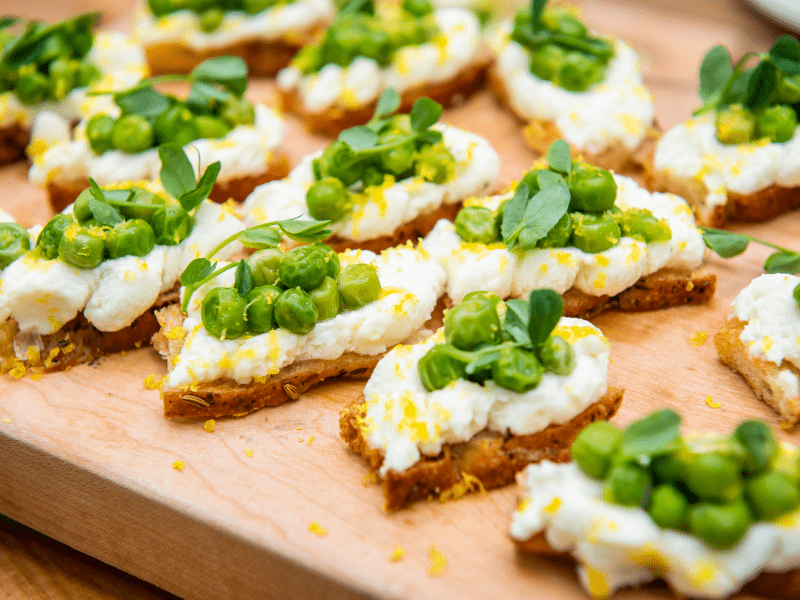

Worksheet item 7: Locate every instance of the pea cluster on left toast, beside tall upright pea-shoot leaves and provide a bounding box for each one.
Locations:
[35,187,194,269]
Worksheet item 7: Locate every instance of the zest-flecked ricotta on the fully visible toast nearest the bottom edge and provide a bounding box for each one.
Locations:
[363,317,609,476]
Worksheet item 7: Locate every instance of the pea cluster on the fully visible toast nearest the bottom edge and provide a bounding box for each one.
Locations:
[417,292,575,393]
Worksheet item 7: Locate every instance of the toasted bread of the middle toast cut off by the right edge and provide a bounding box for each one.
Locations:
[714,317,800,429]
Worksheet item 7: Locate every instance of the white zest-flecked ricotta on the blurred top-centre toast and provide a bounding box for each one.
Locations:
[278,8,482,112]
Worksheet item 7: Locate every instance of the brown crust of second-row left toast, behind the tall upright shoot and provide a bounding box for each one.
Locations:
[47,153,289,212]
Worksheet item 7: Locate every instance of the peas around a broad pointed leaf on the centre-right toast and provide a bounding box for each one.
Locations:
[455,162,672,254]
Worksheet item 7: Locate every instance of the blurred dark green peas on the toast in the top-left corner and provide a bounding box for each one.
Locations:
[0,23,101,105]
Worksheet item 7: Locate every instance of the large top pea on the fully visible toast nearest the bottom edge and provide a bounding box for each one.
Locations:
[444,296,500,350]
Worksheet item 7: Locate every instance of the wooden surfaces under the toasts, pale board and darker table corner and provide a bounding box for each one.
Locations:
[0,0,800,600]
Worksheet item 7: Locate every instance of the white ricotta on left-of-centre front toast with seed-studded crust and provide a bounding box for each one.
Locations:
[167,246,445,387]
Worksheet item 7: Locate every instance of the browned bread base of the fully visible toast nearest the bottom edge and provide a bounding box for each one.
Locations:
[339,388,623,510]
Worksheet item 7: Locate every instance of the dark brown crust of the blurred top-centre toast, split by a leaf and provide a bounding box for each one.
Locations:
[280,54,490,137]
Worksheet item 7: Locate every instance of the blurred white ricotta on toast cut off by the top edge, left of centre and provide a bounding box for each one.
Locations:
[133,0,335,51]
